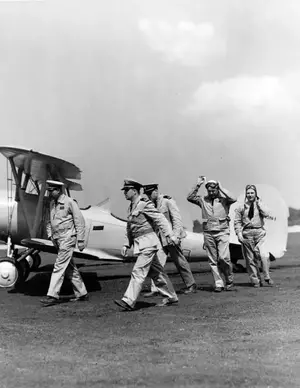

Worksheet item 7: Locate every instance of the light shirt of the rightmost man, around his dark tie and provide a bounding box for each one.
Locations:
[234,201,274,234]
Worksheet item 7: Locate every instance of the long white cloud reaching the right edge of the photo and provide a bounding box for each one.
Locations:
[185,74,300,125]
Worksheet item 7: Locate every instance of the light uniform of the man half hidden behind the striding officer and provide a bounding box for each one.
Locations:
[151,194,195,292]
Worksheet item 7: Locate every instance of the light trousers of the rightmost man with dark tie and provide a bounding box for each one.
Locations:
[241,228,270,284]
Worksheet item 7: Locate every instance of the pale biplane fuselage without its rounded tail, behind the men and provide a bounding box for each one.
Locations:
[0,191,207,261]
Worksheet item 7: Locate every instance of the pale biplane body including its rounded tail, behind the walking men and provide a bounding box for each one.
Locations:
[0,187,288,261]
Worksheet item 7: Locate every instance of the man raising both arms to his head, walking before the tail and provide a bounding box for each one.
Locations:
[187,176,236,292]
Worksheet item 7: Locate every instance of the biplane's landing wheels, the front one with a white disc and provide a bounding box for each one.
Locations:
[0,249,37,288]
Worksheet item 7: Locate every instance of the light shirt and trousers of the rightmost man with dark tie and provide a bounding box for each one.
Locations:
[234,201,273,285]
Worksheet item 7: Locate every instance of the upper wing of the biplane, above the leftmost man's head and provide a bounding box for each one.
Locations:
[0,147,82,191]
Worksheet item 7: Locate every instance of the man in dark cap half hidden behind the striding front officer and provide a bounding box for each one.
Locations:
[144,183,197,297]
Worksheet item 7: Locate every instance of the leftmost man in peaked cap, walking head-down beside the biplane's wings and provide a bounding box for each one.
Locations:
[41,180,88,306]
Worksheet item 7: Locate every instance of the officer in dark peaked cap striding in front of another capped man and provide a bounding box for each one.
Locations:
[114,179,178,311]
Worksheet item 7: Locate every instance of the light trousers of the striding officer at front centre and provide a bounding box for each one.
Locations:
[122,247,178,307]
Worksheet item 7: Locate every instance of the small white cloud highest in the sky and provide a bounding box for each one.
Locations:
[139,19,226,66]
